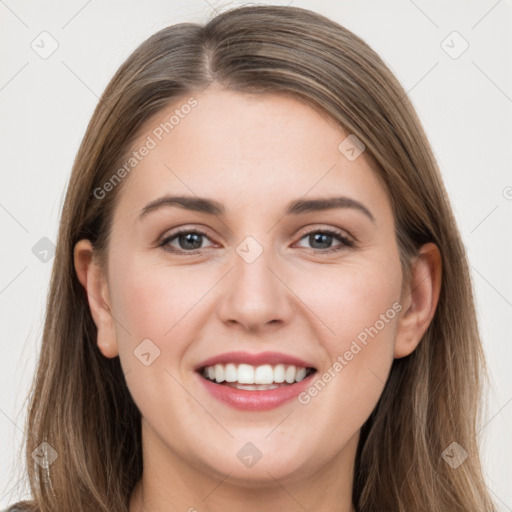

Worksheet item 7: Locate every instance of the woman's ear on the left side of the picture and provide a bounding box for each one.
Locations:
[74,240,119,357]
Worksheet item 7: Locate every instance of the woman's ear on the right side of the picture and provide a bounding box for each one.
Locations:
[395,243,442,359]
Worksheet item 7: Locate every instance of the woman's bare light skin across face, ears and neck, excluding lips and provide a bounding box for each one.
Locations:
[75,84,441,512]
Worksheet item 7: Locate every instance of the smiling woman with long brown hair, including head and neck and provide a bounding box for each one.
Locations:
[6,6,495,512]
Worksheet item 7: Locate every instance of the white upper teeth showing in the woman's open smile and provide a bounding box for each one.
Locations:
[203,363,310,389]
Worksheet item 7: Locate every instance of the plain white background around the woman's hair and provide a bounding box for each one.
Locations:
[0,0,512,511]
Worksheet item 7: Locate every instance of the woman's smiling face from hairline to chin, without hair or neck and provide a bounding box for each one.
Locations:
[82,86,416,485]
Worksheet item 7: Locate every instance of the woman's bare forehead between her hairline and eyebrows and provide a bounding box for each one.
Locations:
[114,86,389,222]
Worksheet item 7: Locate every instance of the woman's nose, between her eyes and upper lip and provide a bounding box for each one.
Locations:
[218,242,293,333]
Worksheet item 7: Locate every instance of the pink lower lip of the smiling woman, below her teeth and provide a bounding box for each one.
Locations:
[197,372,316,411]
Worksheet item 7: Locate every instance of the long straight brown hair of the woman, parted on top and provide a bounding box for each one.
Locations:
[7,6,495,512]
